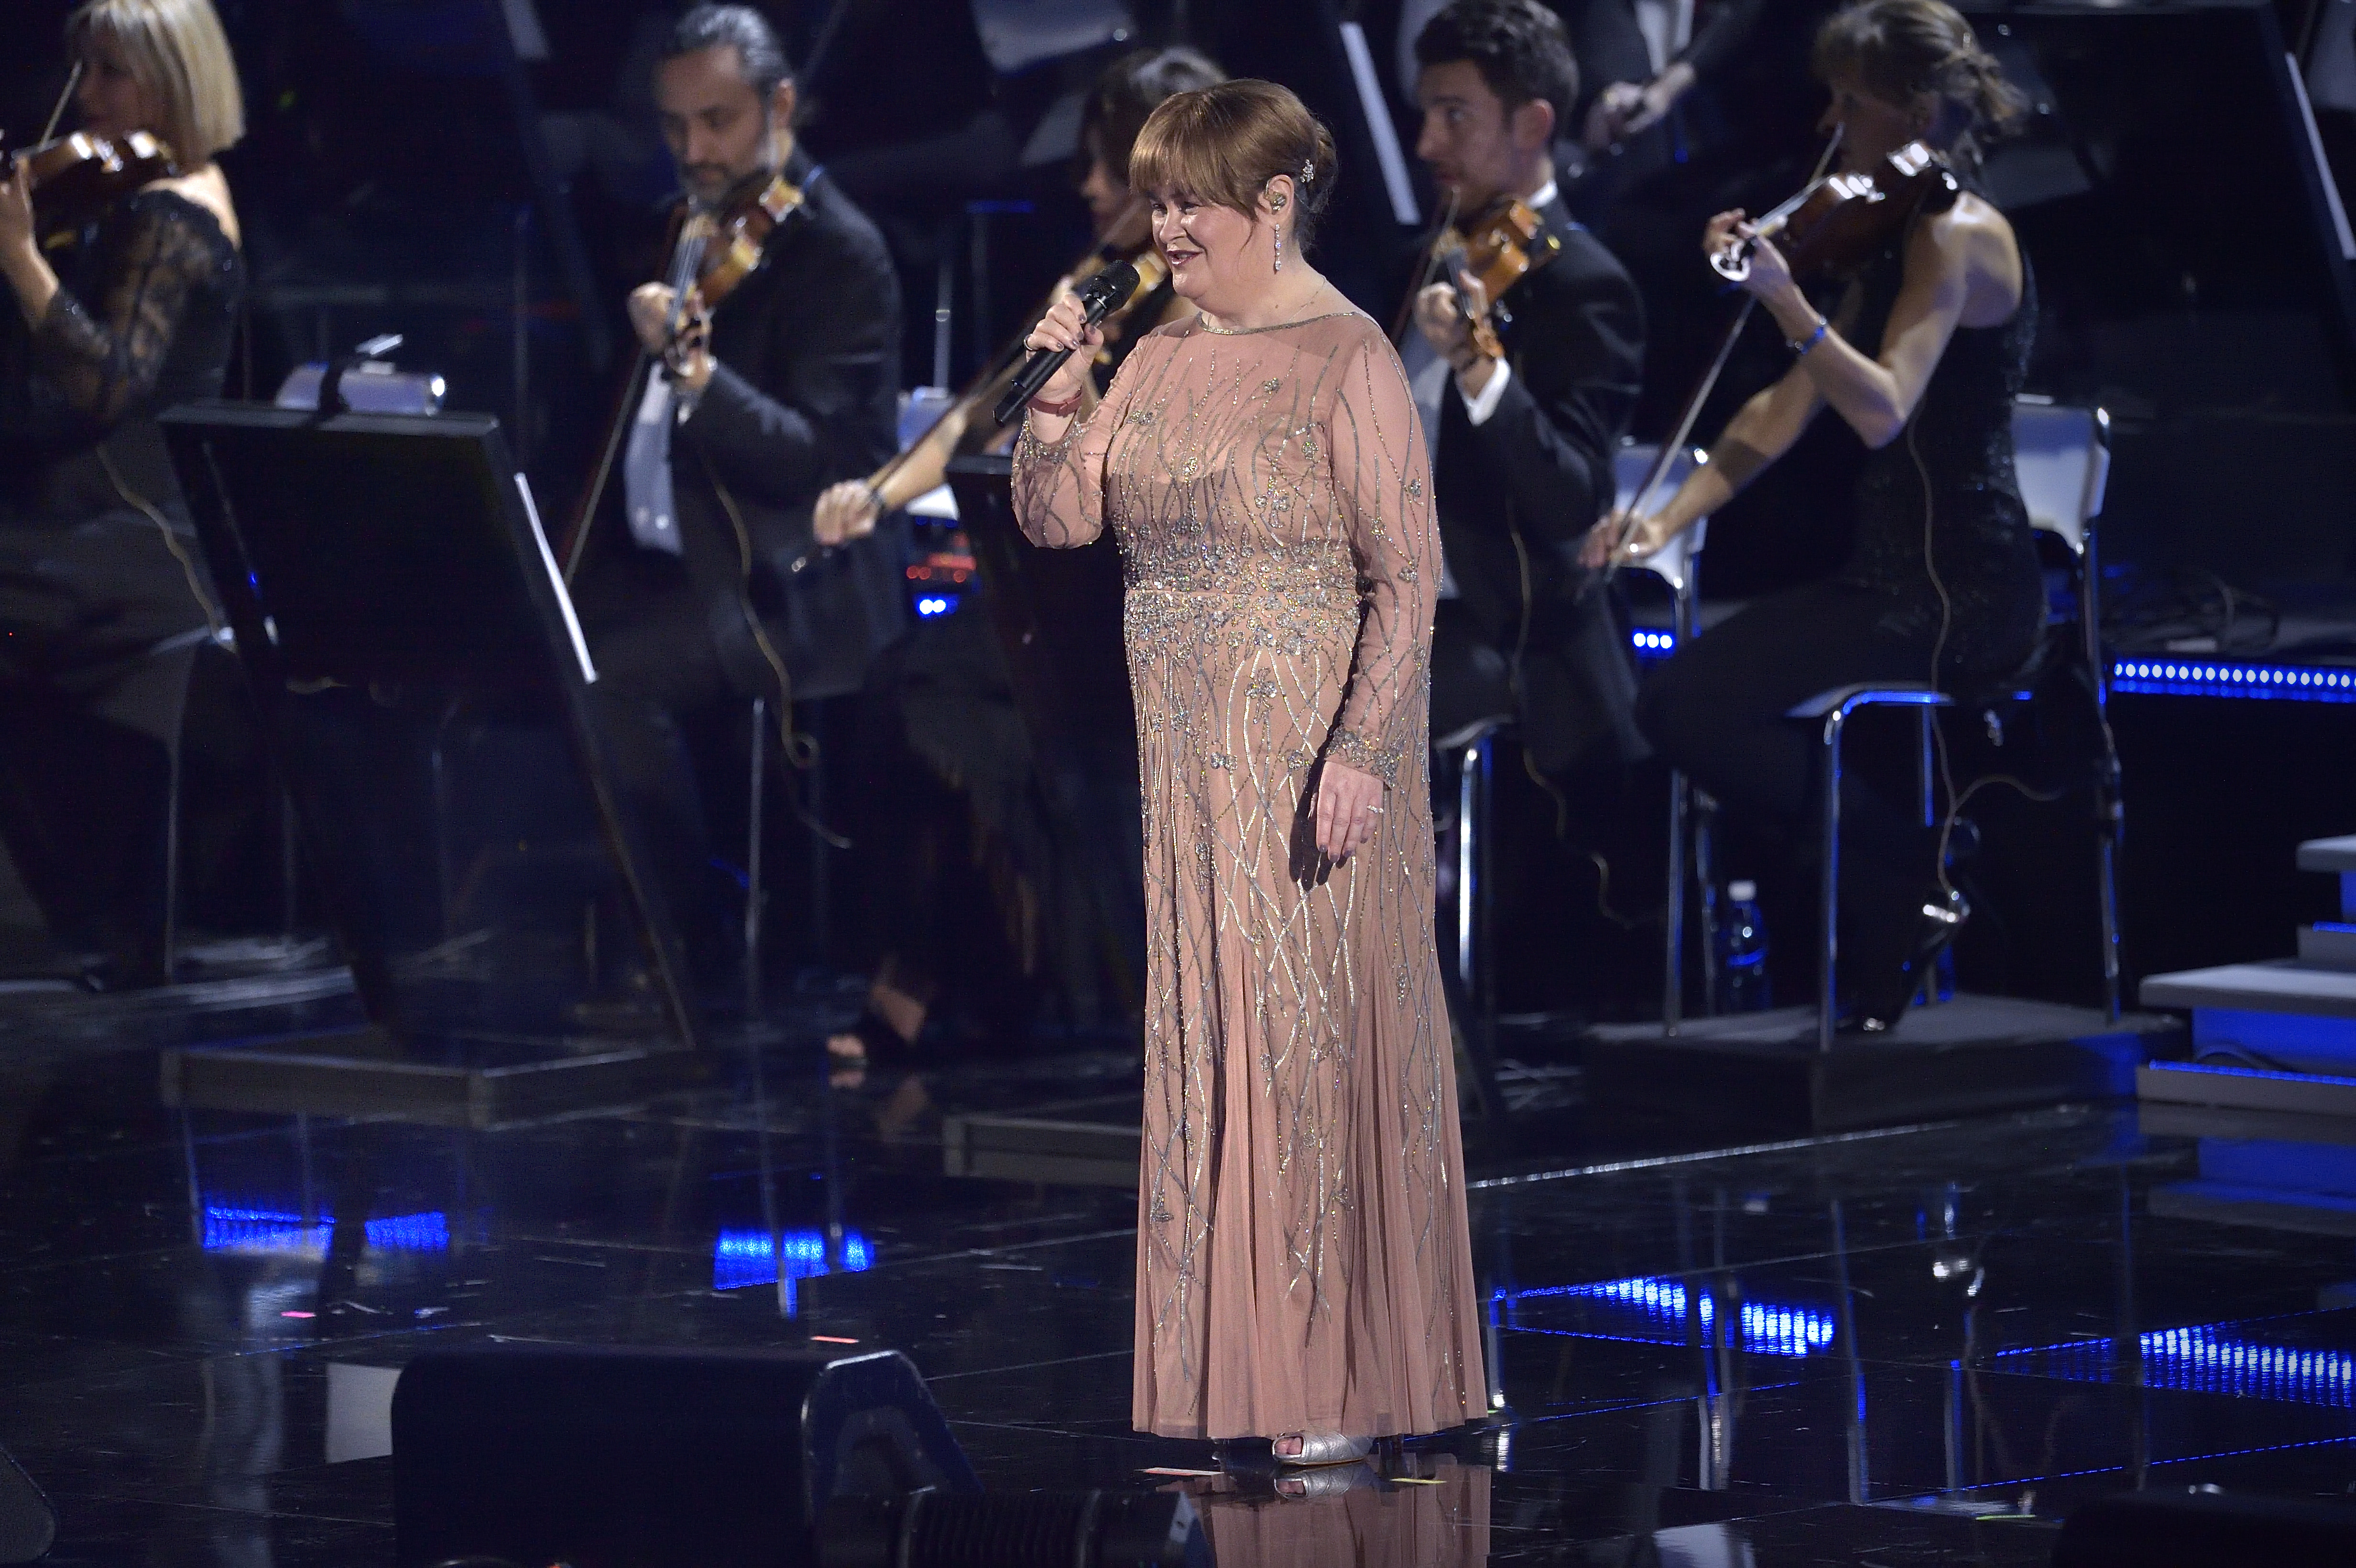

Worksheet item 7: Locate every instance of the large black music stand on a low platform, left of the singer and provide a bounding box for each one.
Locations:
[163,403,700,1125]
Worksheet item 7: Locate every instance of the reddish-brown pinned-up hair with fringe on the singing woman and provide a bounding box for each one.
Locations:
[1129,78,1338,250]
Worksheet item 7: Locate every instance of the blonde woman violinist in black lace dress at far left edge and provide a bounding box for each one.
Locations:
[0,0,245,984]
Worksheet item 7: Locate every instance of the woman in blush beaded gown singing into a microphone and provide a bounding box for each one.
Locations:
[1013,80,1487,1464]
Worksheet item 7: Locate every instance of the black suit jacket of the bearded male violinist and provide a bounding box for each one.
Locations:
[671,148,907,697]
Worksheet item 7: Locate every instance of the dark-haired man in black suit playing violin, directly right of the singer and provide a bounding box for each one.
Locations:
[1404,0,1645,784]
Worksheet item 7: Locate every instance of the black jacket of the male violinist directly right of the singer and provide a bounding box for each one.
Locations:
[1432,198,1645,774]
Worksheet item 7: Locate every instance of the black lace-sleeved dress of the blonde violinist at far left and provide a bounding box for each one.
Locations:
[0,191,245,972]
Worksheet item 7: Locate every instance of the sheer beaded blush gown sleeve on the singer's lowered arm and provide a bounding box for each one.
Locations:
[1329,337,1440,784]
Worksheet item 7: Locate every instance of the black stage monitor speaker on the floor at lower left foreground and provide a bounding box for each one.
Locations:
[393,1344,980,1568]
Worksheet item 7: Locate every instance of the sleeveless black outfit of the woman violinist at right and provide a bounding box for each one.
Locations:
[1637,199,2045,881]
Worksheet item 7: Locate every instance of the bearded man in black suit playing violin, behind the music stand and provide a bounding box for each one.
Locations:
[582,5,905,991]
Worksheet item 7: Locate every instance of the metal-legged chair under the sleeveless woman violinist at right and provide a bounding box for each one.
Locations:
[1790,395,2118,1050]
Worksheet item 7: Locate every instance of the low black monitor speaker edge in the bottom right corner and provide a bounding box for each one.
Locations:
[2054,1492,2356,1568]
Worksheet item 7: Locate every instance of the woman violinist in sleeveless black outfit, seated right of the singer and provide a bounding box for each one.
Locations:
[1586,0,2045,1034]
